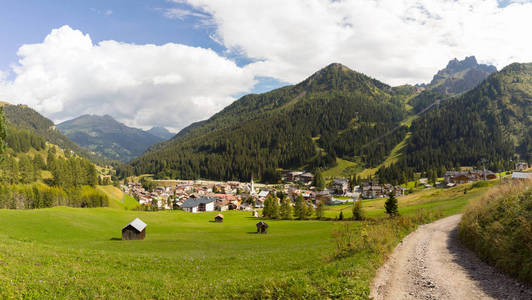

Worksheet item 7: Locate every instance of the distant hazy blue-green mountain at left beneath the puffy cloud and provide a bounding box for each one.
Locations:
[57,115,163,162]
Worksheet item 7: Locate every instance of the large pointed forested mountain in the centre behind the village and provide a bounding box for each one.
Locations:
[121,64,409,181]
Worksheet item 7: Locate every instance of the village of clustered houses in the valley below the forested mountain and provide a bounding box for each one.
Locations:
[121,163,531,213]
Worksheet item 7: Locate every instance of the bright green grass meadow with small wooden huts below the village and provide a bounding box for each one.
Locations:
[0,180,496,299]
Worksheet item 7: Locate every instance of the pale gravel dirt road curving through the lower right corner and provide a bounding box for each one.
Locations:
[370,215,532,300]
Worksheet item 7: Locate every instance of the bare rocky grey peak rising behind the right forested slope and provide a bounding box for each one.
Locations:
[409,56,497,112]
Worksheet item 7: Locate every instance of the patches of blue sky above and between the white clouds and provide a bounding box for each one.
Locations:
[0,0,274,92]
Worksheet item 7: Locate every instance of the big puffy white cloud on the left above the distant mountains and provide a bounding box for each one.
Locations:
[0,26,255,130]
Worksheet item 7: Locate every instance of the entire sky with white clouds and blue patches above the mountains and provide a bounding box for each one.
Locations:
[0,0,532,132]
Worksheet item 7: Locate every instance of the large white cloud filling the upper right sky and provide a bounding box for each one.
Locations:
[183,0,532,84]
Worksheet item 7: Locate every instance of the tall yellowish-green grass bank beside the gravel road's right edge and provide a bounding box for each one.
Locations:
[459,182,532,284]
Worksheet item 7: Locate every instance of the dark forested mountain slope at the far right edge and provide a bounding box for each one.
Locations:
[406,63,532,175]
